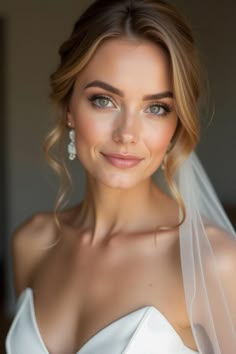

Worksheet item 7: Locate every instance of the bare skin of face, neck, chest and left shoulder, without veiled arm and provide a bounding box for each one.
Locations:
[13,39,199,354]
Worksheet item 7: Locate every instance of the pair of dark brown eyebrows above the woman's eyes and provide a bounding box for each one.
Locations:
[84,80,174,101]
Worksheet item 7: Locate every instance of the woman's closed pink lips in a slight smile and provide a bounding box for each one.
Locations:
[102,153,143,168]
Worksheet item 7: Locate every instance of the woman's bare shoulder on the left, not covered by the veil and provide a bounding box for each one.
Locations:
[12,213,57,295]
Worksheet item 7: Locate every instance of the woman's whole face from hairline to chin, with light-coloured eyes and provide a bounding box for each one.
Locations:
[67,39,178,188]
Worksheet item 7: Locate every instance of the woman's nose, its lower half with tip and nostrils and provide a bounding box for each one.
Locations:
[112,112,139,144]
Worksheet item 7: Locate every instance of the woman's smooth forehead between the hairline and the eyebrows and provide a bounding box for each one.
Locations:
[78,39,172,93]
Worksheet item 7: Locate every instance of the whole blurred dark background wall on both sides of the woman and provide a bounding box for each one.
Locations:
[0,0,236,334]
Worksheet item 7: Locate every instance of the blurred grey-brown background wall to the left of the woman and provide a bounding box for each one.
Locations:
[0,0,95,334]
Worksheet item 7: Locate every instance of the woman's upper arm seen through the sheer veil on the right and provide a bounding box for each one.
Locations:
[194,228,236,354]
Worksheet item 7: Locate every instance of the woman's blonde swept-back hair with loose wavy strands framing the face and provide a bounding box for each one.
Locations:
[44,0,200,238]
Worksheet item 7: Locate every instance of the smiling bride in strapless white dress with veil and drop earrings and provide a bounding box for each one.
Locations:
[6,0,236,354]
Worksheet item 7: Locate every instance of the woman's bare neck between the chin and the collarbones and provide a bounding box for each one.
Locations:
[76,176,167,242]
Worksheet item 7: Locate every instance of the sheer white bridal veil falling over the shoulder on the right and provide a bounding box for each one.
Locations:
[176,152,236,354]
